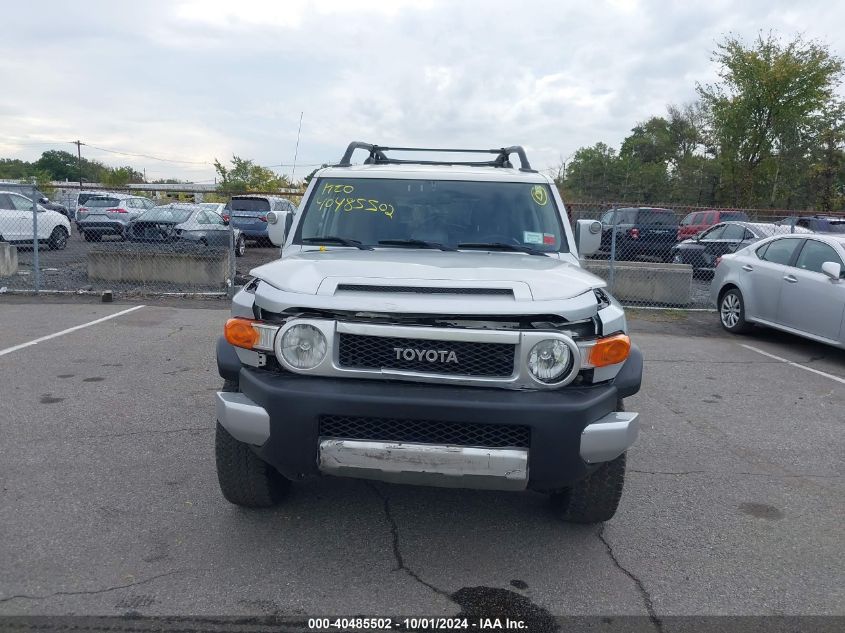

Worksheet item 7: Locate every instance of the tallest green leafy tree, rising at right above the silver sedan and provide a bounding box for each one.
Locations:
[697,34,843,206]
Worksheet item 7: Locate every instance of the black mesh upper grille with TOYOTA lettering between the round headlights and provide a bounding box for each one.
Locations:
[338,334,515,378]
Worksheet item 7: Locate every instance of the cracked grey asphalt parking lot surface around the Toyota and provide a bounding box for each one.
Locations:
[0,300,845,617]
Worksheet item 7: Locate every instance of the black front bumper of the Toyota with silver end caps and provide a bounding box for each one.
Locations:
[217,348,642,490]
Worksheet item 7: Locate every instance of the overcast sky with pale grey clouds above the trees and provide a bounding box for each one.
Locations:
[0,0,845,182]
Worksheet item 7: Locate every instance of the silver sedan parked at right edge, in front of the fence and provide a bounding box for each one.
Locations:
[710,234,845,348]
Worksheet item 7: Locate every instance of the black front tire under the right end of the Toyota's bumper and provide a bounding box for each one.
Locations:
[552,453,625,523]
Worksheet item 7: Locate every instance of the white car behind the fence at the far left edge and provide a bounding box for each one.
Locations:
[0,191,70,250]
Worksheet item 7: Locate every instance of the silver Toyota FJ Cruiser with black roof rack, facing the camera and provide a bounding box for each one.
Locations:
[216,143,642,523]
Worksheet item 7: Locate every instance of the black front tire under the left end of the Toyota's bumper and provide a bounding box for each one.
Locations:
[214,380,290,508]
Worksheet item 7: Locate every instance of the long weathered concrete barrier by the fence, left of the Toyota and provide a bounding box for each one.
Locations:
[88,243,229,288]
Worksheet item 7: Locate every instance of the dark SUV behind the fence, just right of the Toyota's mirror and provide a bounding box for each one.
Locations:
[599,207,678,261]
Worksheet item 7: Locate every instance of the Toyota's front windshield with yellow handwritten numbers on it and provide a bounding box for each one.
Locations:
[294,178,568,252]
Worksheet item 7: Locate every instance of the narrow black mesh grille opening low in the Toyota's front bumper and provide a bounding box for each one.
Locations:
[320,415,531,448]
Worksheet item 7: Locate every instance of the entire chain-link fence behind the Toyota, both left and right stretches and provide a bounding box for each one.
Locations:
[0,185,845,309]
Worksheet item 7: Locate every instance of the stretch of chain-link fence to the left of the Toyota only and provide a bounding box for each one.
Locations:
[0,186,304,297]
